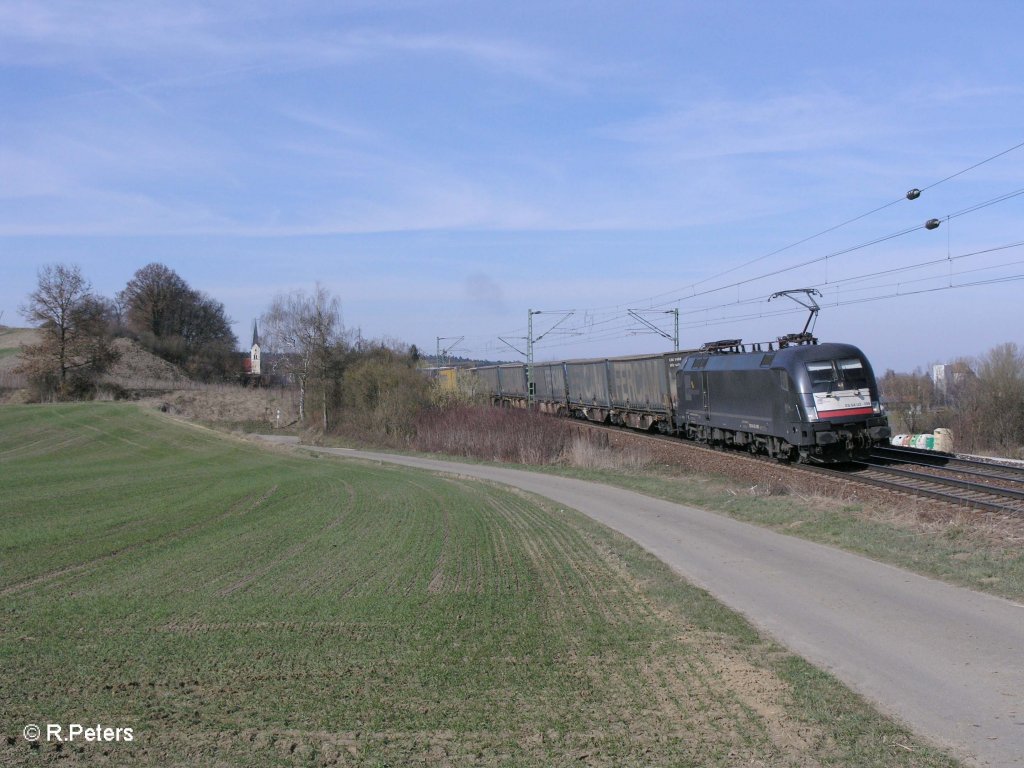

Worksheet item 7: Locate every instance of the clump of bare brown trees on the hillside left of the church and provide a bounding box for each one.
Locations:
[19,263,238,399]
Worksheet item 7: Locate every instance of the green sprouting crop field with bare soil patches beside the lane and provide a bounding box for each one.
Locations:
[0,403,954,766]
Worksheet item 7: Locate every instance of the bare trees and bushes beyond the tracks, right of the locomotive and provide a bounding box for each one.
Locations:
[879,342,1024,456]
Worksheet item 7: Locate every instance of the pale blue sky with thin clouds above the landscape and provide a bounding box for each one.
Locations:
[0,0,1024,370]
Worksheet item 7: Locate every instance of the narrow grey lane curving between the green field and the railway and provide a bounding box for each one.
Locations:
[258,438,1024,766]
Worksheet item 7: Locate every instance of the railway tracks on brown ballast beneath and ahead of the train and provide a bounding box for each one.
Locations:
[579,422,1024,516]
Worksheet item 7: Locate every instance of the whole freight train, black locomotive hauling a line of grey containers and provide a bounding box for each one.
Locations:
[474,335,891,464]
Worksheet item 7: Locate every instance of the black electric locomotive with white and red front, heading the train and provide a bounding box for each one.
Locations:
[675,340,890,463]
